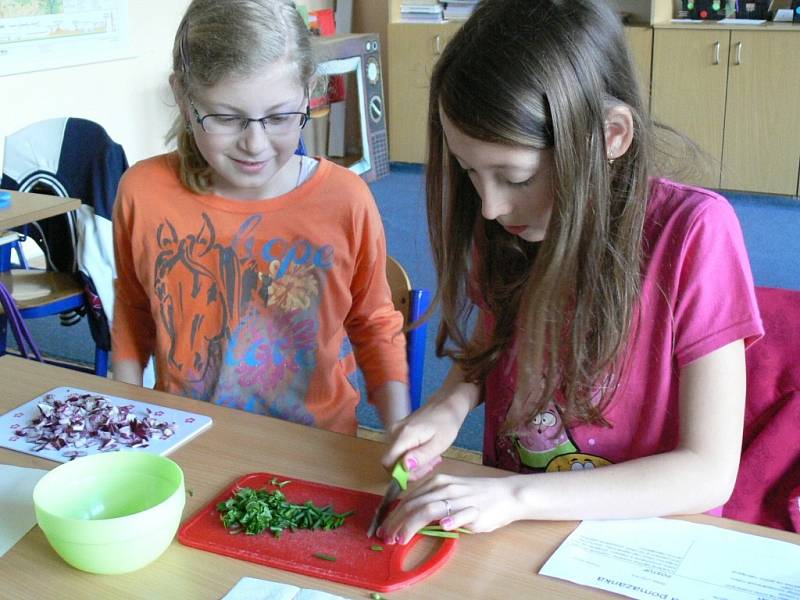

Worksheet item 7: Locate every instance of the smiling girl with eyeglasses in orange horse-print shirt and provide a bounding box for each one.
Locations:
[112,0,409,434]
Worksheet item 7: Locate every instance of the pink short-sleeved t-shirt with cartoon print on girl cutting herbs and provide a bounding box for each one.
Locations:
[484,179,763,472]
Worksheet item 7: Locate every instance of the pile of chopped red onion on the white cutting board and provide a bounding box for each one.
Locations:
[15,392,177,459]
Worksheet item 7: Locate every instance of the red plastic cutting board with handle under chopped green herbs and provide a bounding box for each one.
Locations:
[178,473,456,592]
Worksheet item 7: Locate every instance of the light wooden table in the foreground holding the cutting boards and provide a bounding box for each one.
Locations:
[0,356,800,600]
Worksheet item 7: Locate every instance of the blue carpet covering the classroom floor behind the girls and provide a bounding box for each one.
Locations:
[9,163,800,450]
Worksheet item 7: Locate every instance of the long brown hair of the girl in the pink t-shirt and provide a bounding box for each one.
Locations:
[426,0,652,428]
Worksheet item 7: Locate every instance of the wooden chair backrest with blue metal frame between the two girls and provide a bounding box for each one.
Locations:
[386,256,431,410]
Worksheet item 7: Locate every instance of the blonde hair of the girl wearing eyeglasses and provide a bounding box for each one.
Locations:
[166,0,316,194]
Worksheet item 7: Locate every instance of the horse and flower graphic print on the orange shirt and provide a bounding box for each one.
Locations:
[154,213,333,425]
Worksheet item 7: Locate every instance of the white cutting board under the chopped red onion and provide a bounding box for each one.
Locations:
[0,387,211,462]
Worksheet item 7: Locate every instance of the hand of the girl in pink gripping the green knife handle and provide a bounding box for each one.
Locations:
[382,382,477,481]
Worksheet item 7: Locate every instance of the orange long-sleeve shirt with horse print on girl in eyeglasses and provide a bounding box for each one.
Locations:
[112,154,408,433]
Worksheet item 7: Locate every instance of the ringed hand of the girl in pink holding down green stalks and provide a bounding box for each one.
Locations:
[378,475,524,544]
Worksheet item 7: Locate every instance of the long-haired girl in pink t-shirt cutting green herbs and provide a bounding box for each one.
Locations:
[379,0,763,543]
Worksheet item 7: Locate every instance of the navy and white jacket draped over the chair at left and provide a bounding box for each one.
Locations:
[0,117,128,348]
